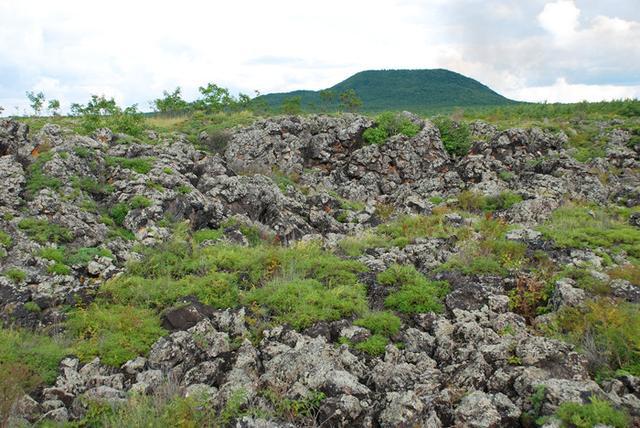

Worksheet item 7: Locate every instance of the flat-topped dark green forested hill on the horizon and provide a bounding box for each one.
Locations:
[260,69,516,112]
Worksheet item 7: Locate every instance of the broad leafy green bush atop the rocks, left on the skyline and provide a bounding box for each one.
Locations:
[71,95,144,137]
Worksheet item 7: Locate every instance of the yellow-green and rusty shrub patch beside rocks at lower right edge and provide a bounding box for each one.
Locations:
[553,298,640,376]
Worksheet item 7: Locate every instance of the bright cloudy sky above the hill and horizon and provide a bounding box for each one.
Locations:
[0,0,640,114]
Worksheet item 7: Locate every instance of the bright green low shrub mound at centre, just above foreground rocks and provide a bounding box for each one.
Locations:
[245,279,367,329]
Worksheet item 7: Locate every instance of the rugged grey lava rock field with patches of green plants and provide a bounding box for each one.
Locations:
[0,113,640,427]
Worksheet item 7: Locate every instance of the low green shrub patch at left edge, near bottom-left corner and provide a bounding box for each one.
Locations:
[0,328,68,384]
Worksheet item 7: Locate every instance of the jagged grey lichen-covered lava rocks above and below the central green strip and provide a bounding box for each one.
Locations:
[0,113,640,427]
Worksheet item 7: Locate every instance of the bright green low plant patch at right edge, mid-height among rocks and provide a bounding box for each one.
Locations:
[539,204,640,258]
